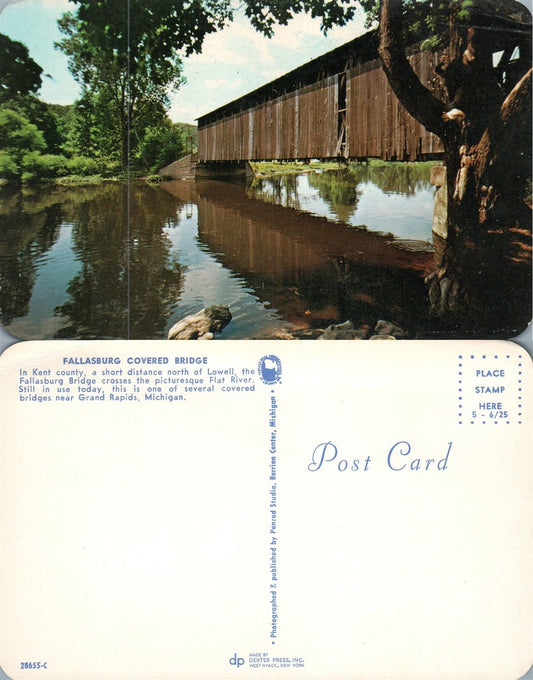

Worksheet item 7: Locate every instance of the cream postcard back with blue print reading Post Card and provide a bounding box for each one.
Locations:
[0,341,532,680]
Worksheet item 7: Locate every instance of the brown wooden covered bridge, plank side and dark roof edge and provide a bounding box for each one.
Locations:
[198,31,442,164]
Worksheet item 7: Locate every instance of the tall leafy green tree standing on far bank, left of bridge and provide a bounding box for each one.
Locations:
[57,0,185,167]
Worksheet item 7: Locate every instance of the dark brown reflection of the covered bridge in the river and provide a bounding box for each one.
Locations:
[163,181,433,328]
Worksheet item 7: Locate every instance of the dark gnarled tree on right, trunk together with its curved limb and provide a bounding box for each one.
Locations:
[380,0,531,337]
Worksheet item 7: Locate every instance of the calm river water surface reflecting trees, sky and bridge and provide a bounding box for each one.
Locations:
[0,165,434,339]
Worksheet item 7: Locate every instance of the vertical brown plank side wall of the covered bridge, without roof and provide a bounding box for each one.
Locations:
[198,52,442,162]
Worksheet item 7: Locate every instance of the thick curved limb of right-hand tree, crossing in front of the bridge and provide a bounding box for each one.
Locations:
[378,0,446,138]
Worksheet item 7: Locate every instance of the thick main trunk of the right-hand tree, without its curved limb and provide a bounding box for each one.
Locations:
[436,71,531,337]
